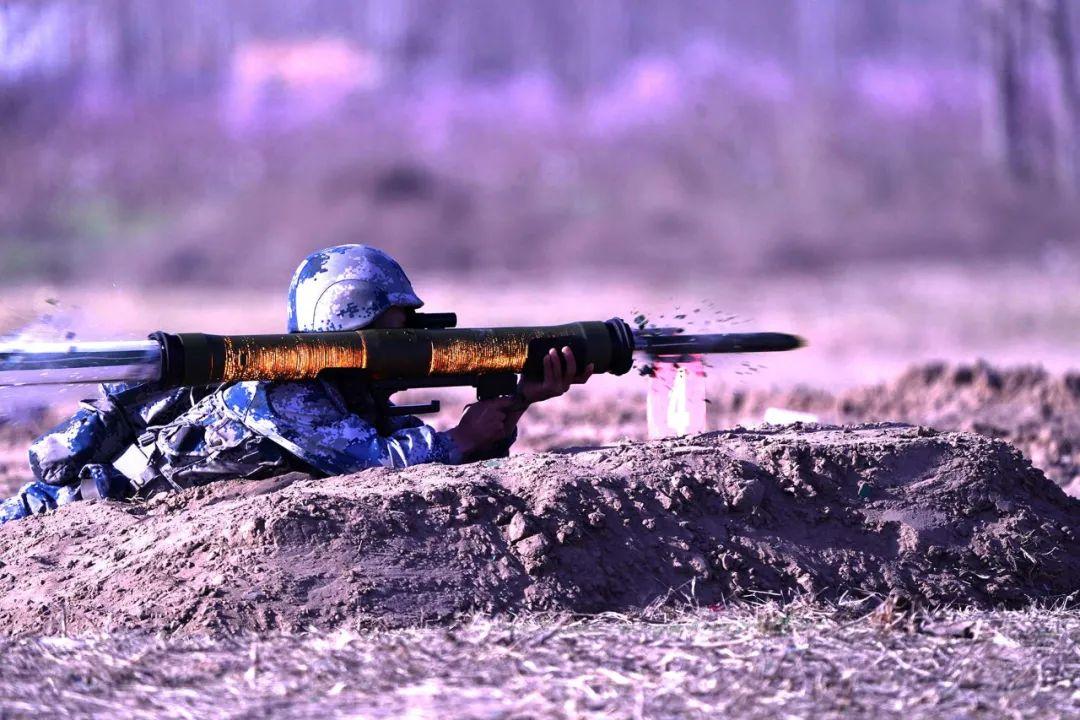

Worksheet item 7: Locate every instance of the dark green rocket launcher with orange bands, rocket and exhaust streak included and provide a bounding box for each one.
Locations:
[0,313,804,415]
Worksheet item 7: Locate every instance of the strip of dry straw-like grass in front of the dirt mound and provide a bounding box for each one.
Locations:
[0,603,1080,718]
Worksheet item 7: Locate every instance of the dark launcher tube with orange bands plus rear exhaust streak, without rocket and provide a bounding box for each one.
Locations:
[0,320,633,386]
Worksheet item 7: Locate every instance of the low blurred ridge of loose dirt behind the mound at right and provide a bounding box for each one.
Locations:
[714,362,1080,489]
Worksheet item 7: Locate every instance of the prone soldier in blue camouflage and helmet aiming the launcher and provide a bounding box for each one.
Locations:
[0,245,593,522]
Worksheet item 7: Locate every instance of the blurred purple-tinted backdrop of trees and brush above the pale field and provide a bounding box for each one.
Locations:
[6,0,1080,294]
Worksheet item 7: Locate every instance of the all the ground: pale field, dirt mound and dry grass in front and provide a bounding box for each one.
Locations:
[0,266,1080,718]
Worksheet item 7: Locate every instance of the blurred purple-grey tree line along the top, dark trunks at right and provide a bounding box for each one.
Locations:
[0,0,1080,189]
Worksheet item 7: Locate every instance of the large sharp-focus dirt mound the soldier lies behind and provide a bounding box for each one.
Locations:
[0,425,1080,634]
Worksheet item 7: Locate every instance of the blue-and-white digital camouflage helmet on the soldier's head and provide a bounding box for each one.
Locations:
[288,245,423,332]
